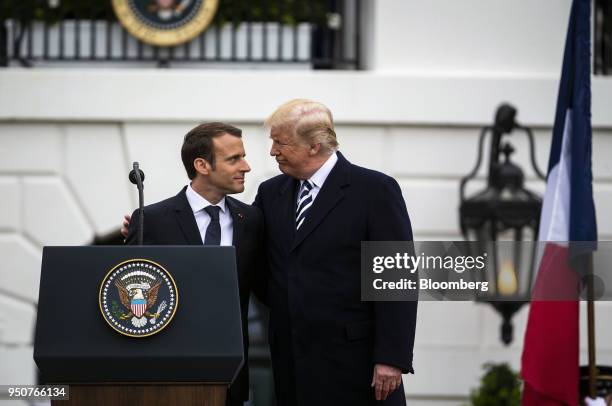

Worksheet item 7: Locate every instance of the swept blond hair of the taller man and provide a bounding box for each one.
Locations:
[264,99,338,154]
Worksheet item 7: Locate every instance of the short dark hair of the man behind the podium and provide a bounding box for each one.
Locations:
[181,122,242,179]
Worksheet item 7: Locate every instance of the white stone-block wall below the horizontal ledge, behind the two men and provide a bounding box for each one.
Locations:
[0,104,612,404]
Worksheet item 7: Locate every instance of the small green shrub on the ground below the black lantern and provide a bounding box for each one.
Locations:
[470,364,521,406]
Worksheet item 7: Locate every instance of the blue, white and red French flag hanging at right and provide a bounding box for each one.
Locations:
[521,0,597,406]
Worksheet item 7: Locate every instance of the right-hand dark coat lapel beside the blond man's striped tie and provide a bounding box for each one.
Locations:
[291,152,350,251]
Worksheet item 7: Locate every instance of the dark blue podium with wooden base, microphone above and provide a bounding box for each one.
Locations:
[34,246,244,406]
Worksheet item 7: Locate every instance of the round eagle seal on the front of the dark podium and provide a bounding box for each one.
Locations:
[99,259,178,337]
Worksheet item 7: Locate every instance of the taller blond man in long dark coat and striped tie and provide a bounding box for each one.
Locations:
[254,100,417,406]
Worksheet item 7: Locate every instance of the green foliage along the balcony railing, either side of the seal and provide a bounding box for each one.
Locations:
[0,0,327,25]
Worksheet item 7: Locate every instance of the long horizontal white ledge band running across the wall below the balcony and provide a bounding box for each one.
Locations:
[0,68,612,128]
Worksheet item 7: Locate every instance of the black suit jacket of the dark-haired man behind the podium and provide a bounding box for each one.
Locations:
[126,187,263,400]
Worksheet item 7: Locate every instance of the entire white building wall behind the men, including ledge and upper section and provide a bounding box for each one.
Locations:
[0,0,612,405]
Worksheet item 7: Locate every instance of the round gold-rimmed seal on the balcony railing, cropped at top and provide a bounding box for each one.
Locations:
[113,0,219,46]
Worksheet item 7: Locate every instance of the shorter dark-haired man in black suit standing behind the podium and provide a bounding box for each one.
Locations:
[124,123,263,406]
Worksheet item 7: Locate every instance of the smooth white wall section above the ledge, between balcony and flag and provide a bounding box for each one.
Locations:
[368,0,571,75]
